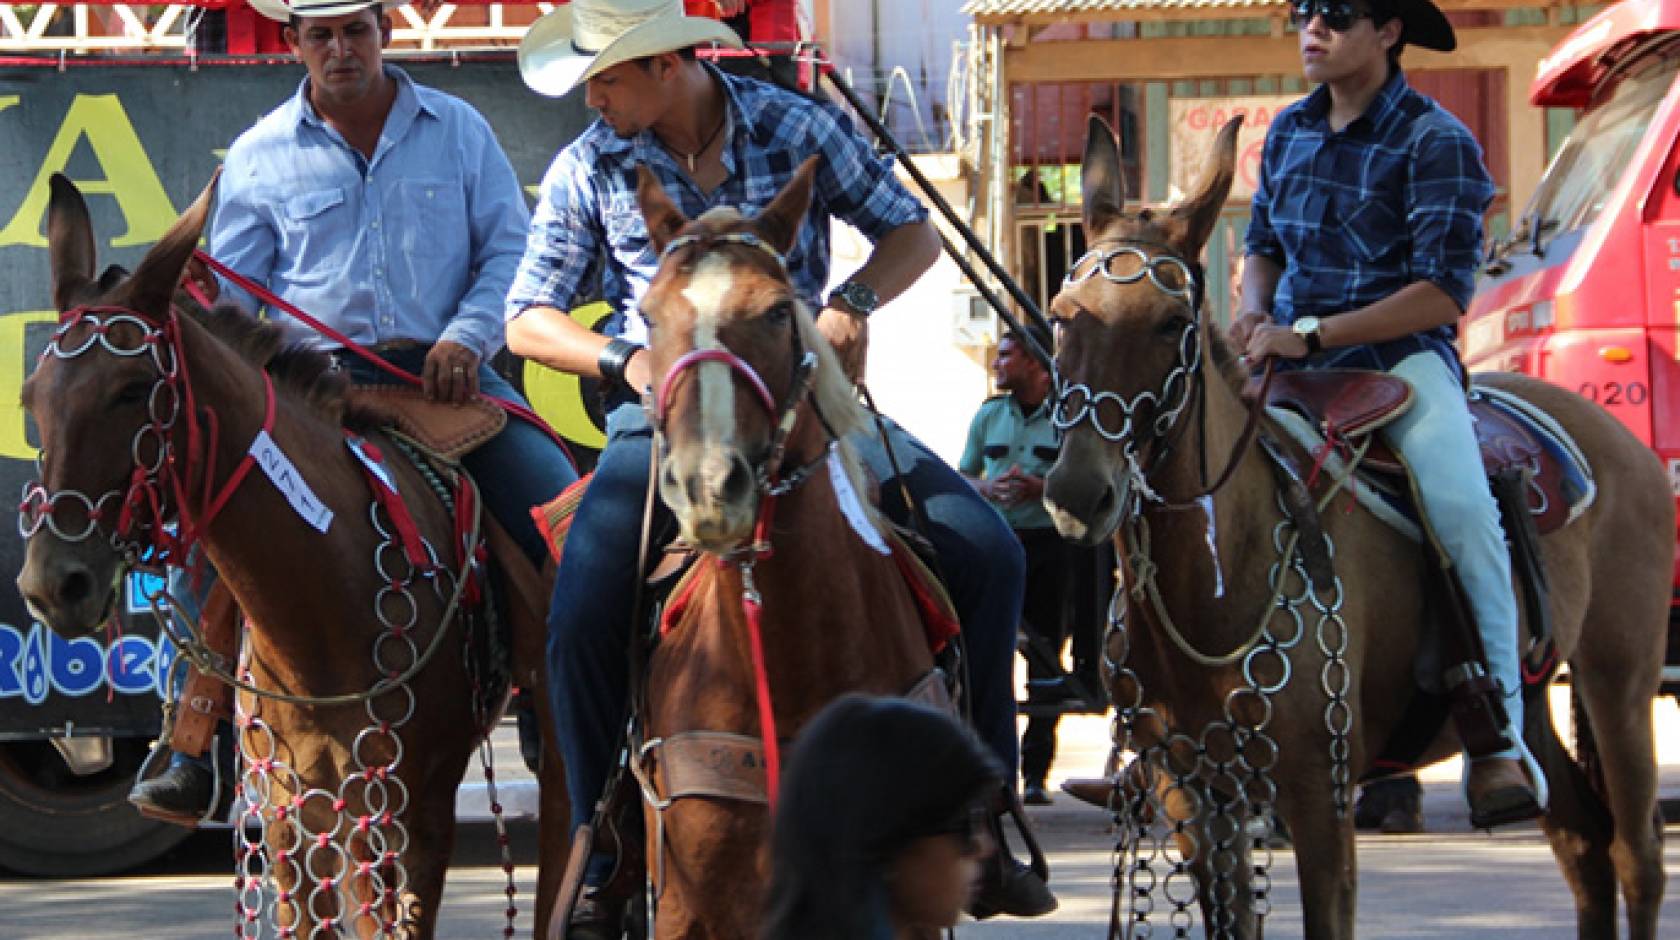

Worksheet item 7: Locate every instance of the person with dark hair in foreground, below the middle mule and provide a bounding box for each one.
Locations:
[761,695,1008,940]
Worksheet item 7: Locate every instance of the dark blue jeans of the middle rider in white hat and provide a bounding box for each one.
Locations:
[548,405,1025,835]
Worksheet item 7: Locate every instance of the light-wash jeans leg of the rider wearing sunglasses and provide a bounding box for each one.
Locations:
[1384,353,1524,815]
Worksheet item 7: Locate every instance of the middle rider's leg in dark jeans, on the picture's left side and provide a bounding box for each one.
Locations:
[548,405,669,856]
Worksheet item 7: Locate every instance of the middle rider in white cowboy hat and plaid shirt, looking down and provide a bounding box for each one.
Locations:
[507,0,1055,937]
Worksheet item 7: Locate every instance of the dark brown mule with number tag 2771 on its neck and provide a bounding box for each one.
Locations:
[18,176,570,937]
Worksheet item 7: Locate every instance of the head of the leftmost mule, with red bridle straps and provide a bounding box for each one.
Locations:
[17,175,215,636]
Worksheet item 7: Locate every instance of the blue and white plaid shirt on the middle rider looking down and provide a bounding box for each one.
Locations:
[506,65,927,342]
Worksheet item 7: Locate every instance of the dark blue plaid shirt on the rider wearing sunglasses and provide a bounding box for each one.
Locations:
[1247,69,1494,371]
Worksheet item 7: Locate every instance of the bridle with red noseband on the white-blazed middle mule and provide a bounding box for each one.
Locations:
[652,232,835,497]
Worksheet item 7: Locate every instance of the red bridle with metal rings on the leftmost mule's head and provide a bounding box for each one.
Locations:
[17,306,274,566]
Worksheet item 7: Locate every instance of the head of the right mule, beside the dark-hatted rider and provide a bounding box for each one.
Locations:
[1045,116,1242,546]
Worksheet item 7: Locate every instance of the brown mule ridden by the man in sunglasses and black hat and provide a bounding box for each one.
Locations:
[1045,119,1675,940]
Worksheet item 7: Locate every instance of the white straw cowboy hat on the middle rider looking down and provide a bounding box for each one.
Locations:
[517,0,741,97]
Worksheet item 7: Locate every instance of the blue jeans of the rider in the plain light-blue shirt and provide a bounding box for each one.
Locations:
[339,346,578,569]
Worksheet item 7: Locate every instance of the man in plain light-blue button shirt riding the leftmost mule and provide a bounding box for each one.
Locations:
[129,0,576,817]
